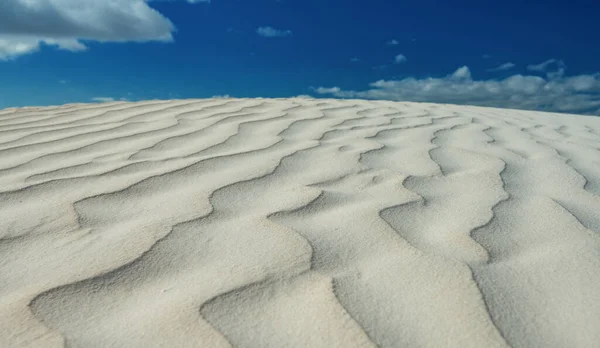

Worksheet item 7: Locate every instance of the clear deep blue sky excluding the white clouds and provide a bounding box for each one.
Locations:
[0,0,600,113]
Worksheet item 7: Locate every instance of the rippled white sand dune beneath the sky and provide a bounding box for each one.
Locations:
[0,99,600,348]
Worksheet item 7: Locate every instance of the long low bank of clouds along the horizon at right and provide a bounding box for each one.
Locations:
[313,66,600,114]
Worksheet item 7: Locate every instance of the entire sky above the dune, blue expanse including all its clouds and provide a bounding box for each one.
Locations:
[0,0,600,114]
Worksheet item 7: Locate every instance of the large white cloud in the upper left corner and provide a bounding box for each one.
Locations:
[0,0,210,60]
